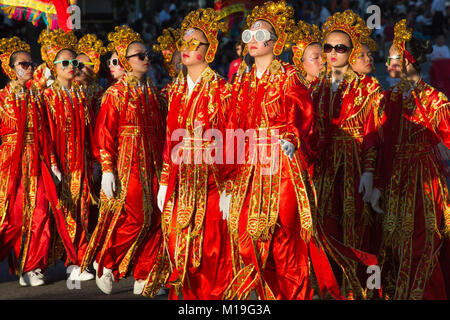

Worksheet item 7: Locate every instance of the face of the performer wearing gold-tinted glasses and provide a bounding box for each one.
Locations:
[180,29,208,67]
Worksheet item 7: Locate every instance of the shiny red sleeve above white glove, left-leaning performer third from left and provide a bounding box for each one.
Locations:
[94,92,119,172]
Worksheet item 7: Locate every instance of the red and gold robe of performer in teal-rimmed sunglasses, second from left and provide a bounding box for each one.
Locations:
[42,81,93,264]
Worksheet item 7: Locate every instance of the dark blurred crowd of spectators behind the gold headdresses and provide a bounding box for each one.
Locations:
[0,0,450,88]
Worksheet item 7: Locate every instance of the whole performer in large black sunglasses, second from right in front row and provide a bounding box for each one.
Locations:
[312,10,382,299]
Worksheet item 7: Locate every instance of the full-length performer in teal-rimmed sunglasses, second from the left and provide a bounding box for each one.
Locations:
[38,29,93,281]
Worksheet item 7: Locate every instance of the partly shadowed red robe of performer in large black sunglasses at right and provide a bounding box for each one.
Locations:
[311,68,382,299]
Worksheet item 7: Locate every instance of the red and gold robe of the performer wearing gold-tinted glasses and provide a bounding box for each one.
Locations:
[160,67,233,300]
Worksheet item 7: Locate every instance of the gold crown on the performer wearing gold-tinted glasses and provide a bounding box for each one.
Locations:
[181,8,226,63]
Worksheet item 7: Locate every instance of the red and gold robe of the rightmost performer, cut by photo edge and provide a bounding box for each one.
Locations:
[378,79,450,300]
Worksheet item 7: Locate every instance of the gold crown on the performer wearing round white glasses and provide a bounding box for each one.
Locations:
[247,0,296,56]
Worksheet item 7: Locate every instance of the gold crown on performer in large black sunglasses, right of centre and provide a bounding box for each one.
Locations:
[322,10,372,64]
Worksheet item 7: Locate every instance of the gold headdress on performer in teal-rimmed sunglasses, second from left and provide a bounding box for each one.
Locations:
[38,29,77,73]
